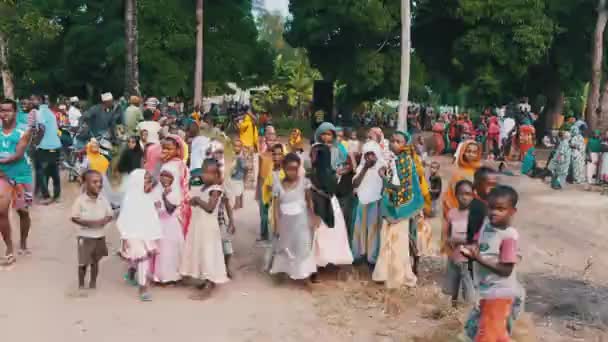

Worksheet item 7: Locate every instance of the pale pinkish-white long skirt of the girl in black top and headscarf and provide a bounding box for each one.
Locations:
[313,196,353,267]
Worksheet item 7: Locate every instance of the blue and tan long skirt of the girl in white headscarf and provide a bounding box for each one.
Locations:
[350,199,382,264]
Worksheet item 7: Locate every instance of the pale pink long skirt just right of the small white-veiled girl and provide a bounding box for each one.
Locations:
[154,215,184,283]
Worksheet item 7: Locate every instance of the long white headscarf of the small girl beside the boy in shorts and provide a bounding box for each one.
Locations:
[116,169,162,241]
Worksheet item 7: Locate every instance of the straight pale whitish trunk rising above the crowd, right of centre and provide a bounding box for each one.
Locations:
[397,0,411,131]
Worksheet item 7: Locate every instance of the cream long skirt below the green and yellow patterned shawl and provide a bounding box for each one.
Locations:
[372,219,418,289]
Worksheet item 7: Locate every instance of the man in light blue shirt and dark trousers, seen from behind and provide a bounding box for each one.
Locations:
[35,96,61,205]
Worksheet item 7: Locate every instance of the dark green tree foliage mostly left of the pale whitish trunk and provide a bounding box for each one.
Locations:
[286,0,427,106]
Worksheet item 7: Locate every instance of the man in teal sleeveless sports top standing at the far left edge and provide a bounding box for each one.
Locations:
[0,99,32,265]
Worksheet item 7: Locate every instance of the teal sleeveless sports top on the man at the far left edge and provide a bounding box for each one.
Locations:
[0,127,32,184]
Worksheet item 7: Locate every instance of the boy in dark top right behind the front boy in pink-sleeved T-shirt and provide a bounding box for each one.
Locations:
[467,167,498,243]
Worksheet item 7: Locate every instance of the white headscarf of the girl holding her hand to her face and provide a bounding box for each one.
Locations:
[355,141,386,204]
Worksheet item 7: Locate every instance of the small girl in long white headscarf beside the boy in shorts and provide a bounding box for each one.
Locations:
[116,169,162,301]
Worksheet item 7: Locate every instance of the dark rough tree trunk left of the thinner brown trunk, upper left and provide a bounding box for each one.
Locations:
[124,0,141,97]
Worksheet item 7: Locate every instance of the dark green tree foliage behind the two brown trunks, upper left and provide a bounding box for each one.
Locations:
[6,0,273,100]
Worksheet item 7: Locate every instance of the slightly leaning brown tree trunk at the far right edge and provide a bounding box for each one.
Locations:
[585,0,608,128]
